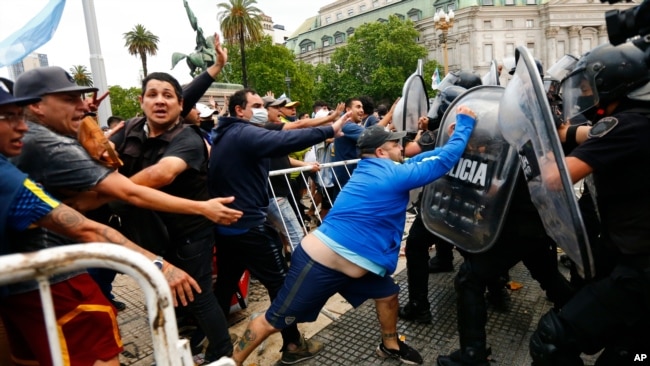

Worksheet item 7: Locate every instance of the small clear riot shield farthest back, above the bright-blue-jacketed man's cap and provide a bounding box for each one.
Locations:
[393,60,429,132]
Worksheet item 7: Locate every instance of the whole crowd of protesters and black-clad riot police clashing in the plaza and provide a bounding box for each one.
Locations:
[0,31,650,366]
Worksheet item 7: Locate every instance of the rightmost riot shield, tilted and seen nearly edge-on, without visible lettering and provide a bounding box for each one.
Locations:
[499,47,594,278]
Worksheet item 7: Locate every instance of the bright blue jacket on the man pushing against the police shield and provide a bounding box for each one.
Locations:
[318,114,474,274]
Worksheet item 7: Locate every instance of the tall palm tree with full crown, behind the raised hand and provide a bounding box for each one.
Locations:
[217,0,264,87]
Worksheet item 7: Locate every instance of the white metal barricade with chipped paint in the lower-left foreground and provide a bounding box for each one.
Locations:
[0,243,235,366]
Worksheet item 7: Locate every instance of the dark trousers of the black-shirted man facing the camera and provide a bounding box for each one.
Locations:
[165,227,233,361]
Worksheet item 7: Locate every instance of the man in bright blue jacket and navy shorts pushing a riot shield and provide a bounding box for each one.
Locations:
[233,106,476,365]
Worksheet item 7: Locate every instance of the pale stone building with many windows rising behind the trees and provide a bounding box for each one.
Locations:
[286,0,634,78]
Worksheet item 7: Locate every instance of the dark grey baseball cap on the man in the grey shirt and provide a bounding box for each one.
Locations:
[14,66,98,98]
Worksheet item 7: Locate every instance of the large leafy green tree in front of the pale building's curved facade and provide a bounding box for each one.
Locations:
[315,15,435,103]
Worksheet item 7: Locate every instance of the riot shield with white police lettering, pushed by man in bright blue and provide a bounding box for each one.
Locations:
[421,86,519,253]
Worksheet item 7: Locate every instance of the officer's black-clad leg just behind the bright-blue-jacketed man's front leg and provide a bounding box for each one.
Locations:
[399,215,435,323]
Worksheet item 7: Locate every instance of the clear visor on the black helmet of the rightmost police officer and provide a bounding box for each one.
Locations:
[561,68,599,121]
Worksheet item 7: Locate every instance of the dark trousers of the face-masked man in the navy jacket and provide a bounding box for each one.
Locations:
[215,224,300,349]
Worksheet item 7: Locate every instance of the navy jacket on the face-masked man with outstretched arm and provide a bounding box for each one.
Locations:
[208,117,334,229]
